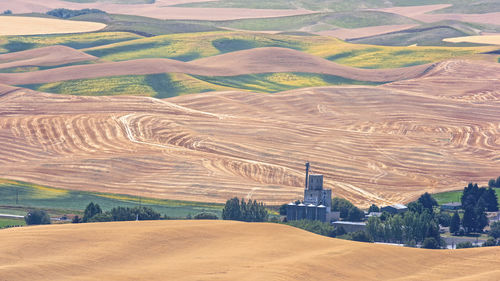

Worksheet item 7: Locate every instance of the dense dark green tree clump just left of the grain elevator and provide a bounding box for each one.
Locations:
[222,197,268,222]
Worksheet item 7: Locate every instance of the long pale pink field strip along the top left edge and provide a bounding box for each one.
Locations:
[0,0,312,20]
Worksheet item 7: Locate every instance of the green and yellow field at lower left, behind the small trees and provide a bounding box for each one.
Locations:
[0,180,223,218]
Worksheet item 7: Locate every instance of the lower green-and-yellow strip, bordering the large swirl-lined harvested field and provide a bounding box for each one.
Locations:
[20,73,376,98]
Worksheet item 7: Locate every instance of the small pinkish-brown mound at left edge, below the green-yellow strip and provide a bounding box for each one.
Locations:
[0,46,97,69]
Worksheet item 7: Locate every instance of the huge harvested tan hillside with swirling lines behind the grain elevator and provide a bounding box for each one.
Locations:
[0,60,500,206]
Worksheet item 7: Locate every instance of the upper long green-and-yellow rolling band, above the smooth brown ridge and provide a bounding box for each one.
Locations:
[84,32,493,68]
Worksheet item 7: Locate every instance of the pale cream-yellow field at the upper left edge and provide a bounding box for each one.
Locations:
[0,16,106,35]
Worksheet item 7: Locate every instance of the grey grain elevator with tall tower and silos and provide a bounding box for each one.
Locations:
[287,162,339,222]
